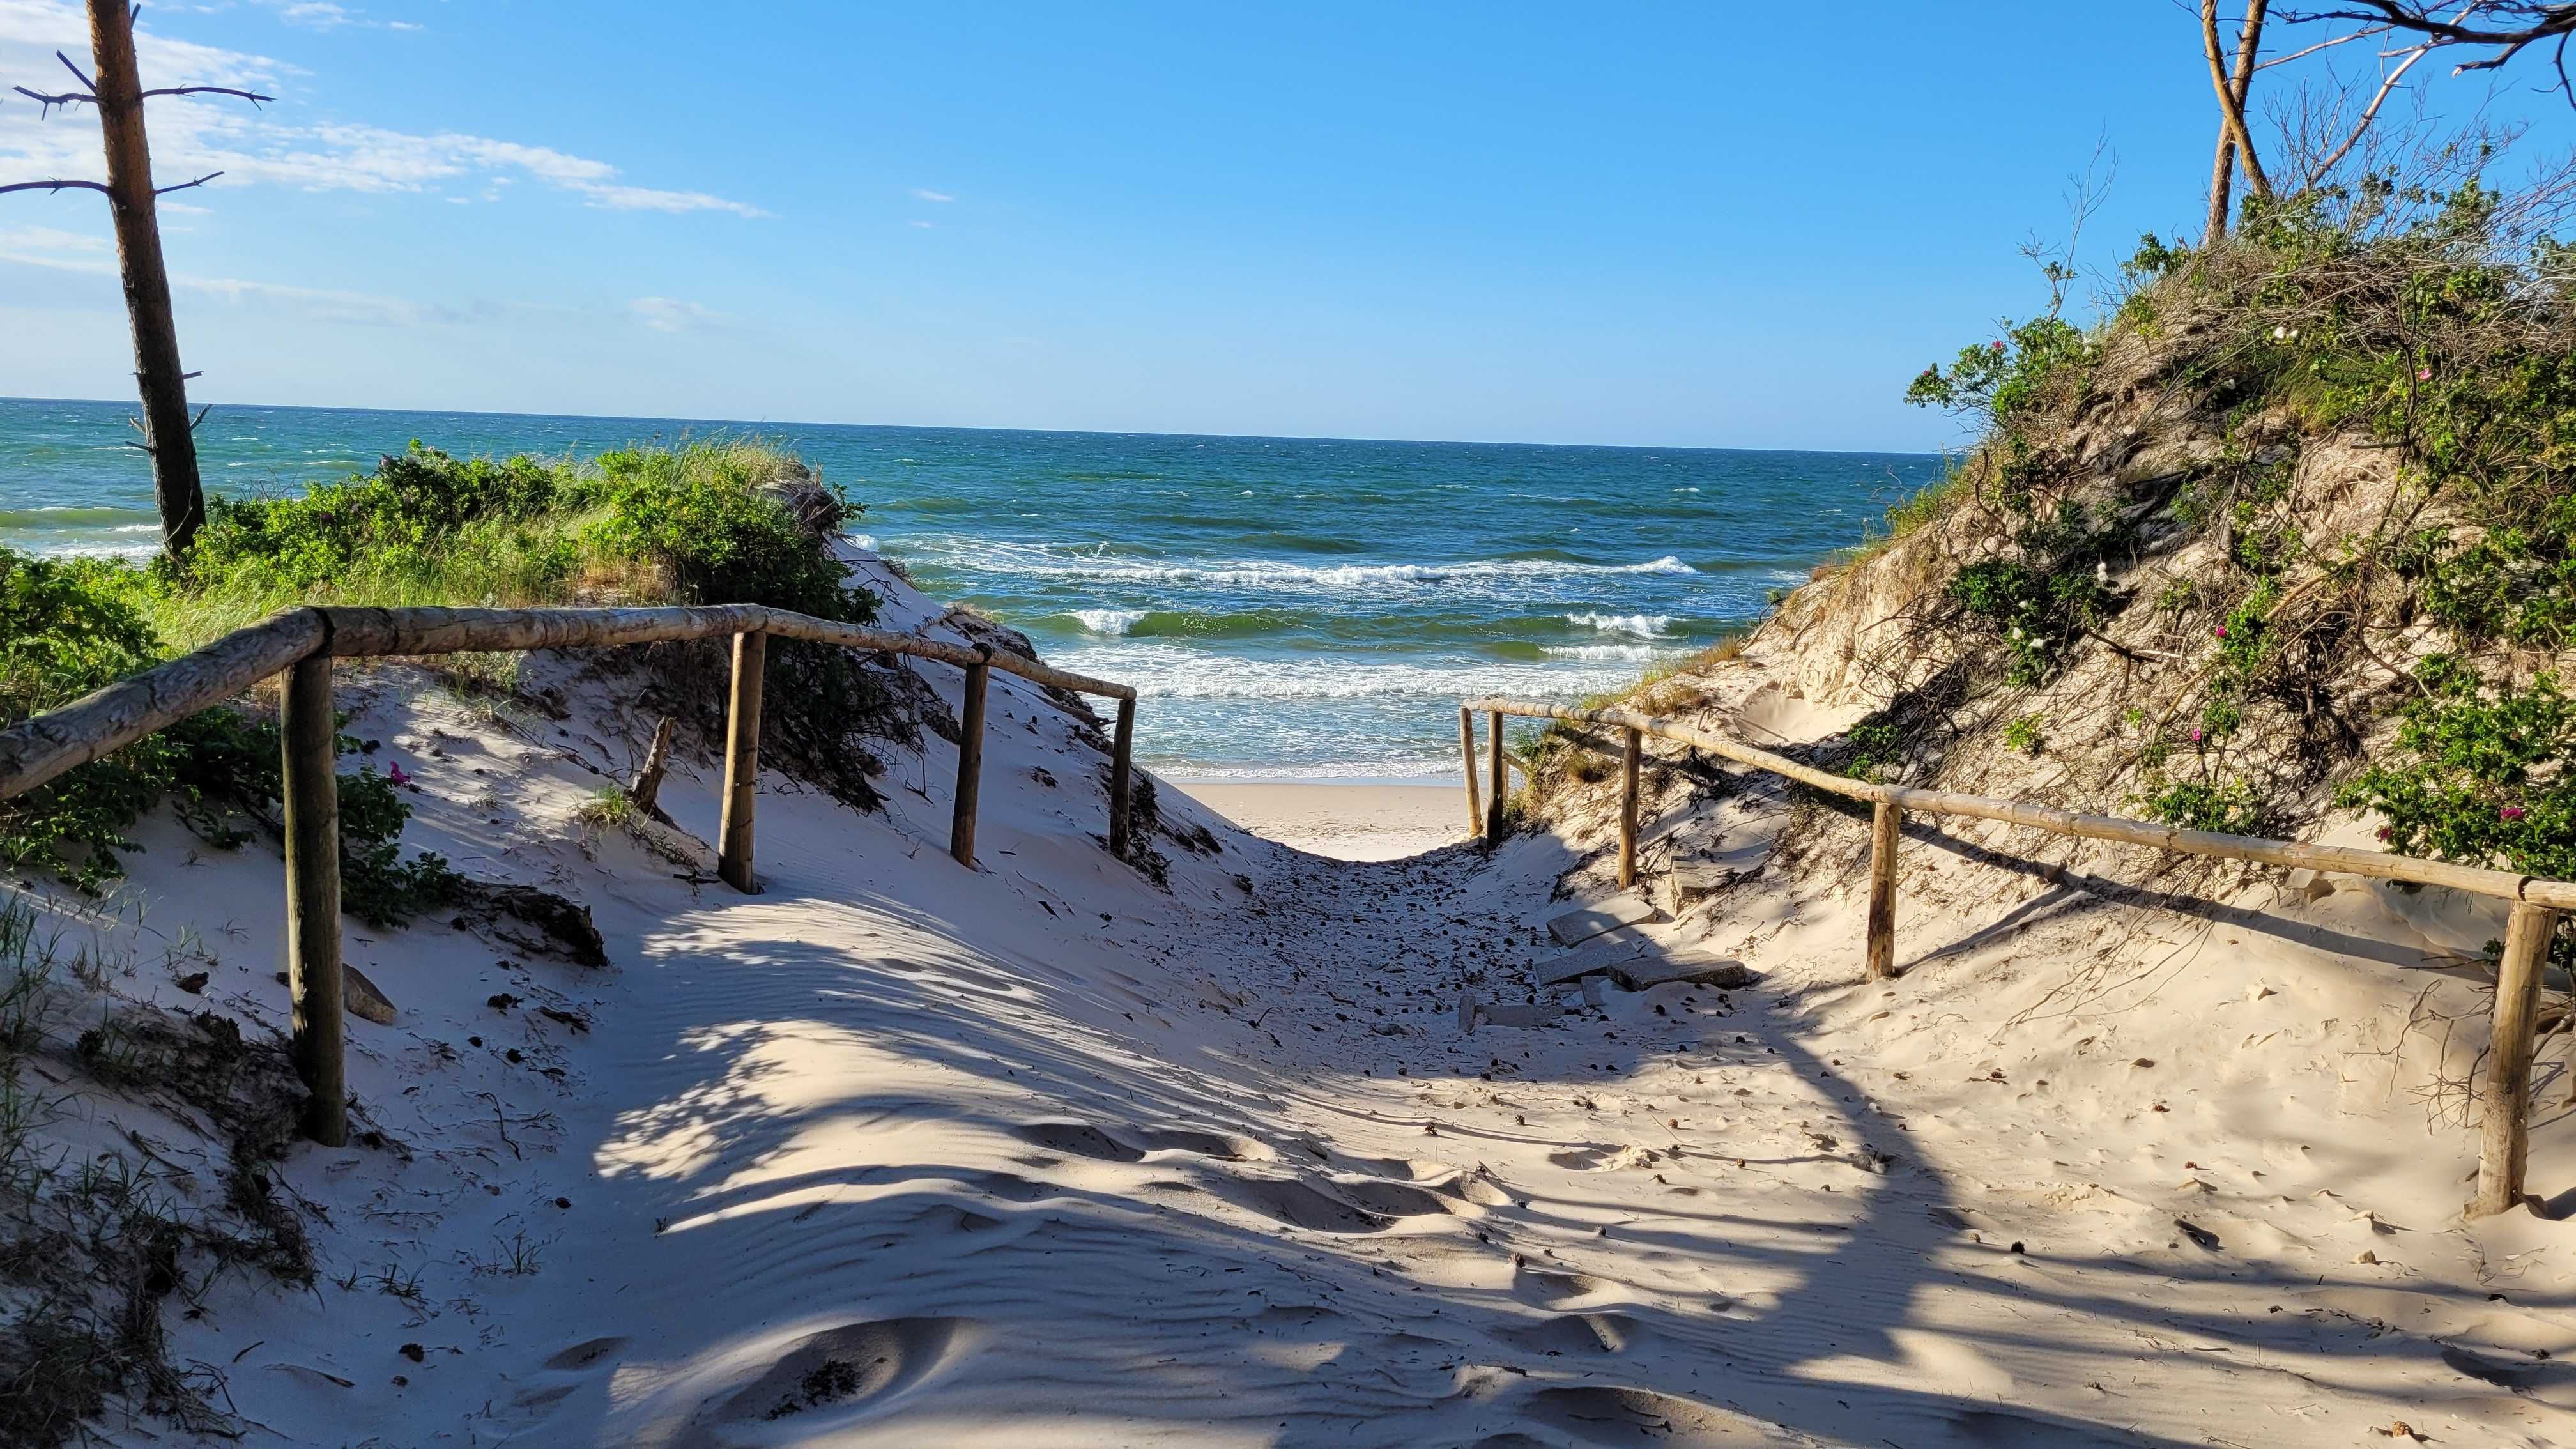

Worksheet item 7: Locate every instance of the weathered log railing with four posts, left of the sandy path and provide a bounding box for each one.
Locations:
[0,603,1136,1147]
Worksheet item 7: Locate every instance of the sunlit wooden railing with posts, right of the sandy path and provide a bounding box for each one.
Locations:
[1458,699,2576,1217]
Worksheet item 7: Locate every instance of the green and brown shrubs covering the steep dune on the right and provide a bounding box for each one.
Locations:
[1852,155,2576,923]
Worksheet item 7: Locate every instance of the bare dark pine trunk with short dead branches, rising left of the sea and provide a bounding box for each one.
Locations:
[0,0,273,560]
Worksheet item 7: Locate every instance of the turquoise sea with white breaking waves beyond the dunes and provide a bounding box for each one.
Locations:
[0,400,1940,779]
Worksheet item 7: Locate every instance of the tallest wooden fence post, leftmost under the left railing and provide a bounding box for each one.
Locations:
[280,655,348,1147]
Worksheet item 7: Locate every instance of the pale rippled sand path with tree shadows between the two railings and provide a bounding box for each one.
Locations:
[20,549,2576,1449]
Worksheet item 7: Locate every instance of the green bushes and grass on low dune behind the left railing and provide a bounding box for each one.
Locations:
[0,438,884,897]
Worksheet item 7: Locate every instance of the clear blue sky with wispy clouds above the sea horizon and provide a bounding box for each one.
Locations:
[0,0,2566,448]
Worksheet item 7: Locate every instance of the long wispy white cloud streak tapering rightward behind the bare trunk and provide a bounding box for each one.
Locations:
[0,0,768,217]
